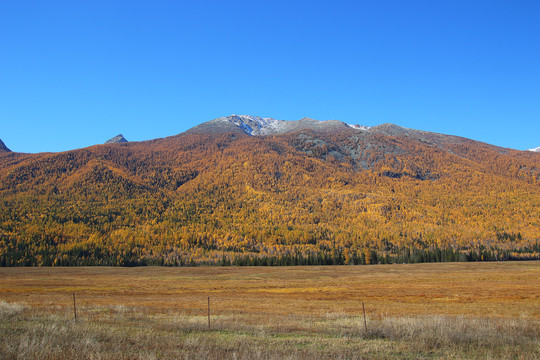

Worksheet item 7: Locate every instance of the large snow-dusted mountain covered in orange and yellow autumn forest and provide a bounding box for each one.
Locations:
[0,115,540,266]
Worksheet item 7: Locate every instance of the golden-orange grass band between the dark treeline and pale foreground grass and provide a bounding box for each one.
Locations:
[0,262,540,318]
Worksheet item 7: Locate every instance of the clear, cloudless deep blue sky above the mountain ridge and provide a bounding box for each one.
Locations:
[0,0,540,152]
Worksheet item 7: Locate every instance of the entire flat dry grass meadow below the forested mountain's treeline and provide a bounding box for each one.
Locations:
[0,262,540,359]
